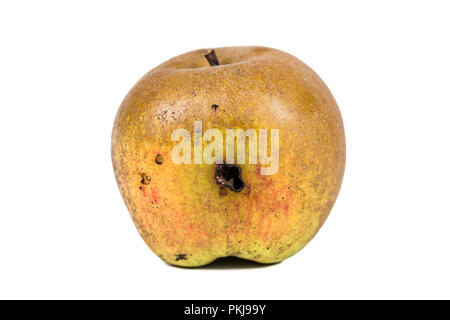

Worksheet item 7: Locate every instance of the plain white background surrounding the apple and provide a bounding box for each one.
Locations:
[0,0,450,299]
